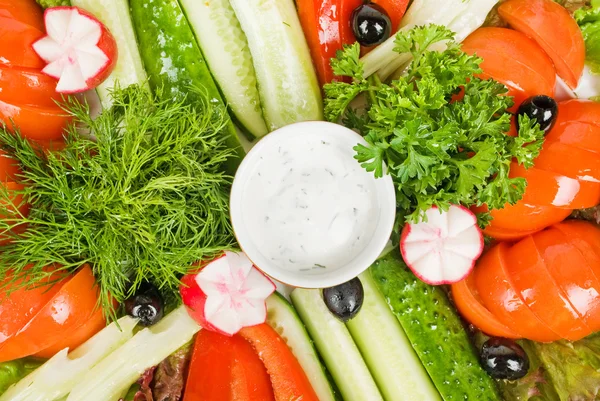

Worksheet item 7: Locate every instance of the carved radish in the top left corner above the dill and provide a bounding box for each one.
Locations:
[33,7,118,94]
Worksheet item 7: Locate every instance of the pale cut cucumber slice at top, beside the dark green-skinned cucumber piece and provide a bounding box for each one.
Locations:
[179,0,268,138]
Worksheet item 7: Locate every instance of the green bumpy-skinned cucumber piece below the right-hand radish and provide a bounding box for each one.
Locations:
[370,251,501,401]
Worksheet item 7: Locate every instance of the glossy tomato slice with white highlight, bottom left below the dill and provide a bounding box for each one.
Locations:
[0,265,98,362]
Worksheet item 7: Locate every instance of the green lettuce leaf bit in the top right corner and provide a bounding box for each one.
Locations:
[575,0,600,74]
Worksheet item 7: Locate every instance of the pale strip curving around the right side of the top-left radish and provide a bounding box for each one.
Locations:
[71,0,147,108]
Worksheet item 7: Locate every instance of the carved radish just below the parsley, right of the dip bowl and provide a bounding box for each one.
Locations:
[400,205,483,285]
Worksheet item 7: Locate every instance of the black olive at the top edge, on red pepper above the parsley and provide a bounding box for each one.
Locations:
[352,4,392,47]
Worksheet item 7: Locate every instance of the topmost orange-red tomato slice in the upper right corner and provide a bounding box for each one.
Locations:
[498,0,585,89]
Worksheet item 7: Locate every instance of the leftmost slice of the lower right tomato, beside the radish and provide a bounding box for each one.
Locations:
[473,242,560,342]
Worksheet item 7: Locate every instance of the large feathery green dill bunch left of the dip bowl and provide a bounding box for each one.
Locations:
[0,87,234,318]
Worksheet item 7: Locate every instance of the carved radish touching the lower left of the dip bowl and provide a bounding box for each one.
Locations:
[180,252,275,336]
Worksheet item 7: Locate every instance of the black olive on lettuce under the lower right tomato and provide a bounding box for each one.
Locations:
[480,337,529,380]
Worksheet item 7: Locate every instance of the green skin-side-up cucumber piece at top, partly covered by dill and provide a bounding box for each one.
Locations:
[129,0,245,174]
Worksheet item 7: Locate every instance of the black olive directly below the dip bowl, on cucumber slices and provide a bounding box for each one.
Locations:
[323,278,365,322]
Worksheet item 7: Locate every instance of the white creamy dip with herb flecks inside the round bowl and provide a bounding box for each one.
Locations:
[240,131,379,272]
